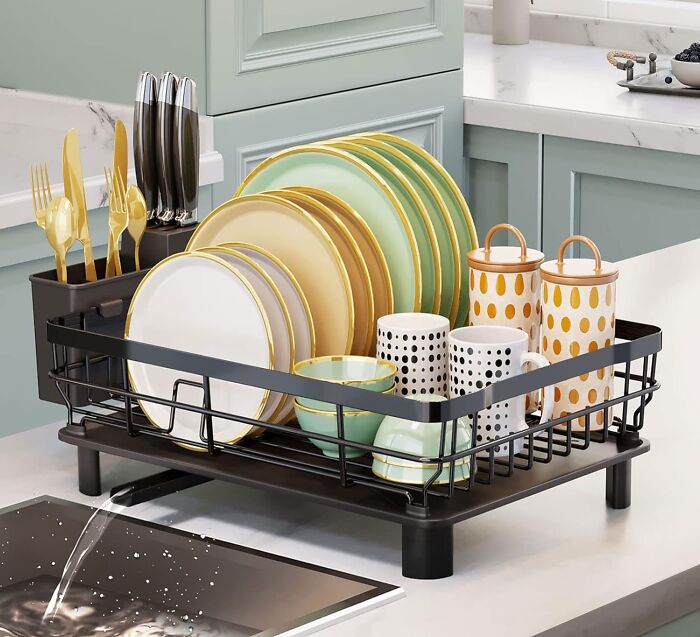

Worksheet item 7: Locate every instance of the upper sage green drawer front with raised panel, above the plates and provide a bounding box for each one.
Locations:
[206,0,463,114]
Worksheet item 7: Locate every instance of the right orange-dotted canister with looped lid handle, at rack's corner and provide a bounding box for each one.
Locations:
[540,235,619,431]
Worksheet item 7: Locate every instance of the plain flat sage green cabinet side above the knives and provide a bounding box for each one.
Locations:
[0,0,207,112]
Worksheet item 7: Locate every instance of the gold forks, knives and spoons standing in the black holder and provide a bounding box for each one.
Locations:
[30,120,147,283]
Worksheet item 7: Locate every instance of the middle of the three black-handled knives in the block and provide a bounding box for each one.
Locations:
[156,73,178,224]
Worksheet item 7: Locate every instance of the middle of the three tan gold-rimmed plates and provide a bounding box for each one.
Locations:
[267,189,376,355]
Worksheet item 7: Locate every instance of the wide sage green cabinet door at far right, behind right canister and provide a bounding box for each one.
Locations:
[543,137,700,261]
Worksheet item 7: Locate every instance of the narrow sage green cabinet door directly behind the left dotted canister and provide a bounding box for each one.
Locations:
[464,126,542,248]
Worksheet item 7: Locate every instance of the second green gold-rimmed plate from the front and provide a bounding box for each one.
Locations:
[330,139,442,313]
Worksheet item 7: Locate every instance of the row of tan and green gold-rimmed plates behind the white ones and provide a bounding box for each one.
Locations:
[188,133,478,356]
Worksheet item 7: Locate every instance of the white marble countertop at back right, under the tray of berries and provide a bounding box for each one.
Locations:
[464,33,700,154]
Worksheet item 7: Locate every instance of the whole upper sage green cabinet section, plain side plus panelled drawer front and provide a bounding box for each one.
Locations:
[0,0,463,115]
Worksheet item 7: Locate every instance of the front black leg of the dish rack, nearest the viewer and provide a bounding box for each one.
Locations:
[401,524,453,579]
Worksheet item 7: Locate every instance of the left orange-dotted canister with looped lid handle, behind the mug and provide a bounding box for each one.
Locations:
[467,223,544,412]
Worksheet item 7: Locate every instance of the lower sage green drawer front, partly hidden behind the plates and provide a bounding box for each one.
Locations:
[213,71,462,206]
